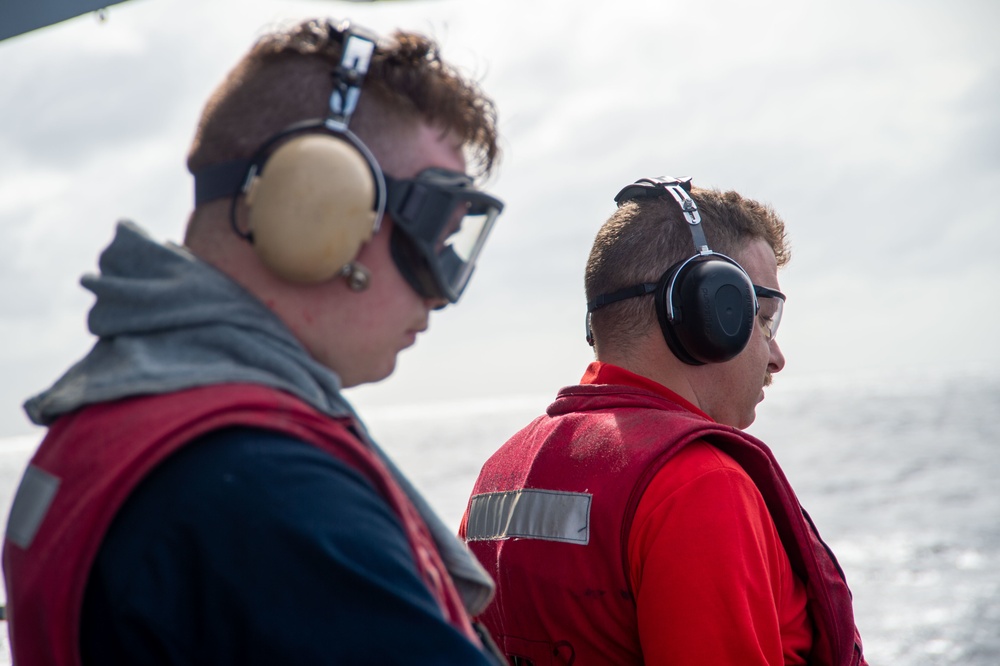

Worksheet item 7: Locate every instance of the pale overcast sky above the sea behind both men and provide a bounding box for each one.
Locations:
[0,0,1000,437]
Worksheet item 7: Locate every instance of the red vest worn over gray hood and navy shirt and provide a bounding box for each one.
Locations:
[3,384,479,666]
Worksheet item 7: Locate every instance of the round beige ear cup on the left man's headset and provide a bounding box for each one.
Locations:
[246,134,376,282]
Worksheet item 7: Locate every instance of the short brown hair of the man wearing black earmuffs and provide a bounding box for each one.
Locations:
[584,187,791,349]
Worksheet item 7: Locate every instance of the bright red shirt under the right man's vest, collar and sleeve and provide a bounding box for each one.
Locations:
[581,363,812,666]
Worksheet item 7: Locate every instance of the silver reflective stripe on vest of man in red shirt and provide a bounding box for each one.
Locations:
[465,488,593,545]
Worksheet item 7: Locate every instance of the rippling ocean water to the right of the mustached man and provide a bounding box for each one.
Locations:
[754,375,1000,666]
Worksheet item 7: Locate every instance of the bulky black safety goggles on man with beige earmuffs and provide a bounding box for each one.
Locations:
[385,169,503,303]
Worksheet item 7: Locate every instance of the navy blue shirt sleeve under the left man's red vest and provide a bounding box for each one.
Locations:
[81,428,492,666]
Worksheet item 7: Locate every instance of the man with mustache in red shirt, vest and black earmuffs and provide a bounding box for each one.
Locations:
[462,178,864,666]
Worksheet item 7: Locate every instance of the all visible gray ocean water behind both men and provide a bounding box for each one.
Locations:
[0,369,1000,666]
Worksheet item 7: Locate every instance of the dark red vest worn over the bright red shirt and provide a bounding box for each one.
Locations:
[461,384,865,666]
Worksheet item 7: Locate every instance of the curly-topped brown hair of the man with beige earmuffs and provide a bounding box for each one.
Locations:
[188,19,499,175]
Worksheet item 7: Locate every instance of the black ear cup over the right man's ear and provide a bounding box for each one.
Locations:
[656,254,756,365]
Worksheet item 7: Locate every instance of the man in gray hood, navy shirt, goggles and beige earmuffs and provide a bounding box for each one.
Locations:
[4,20,503,666]
